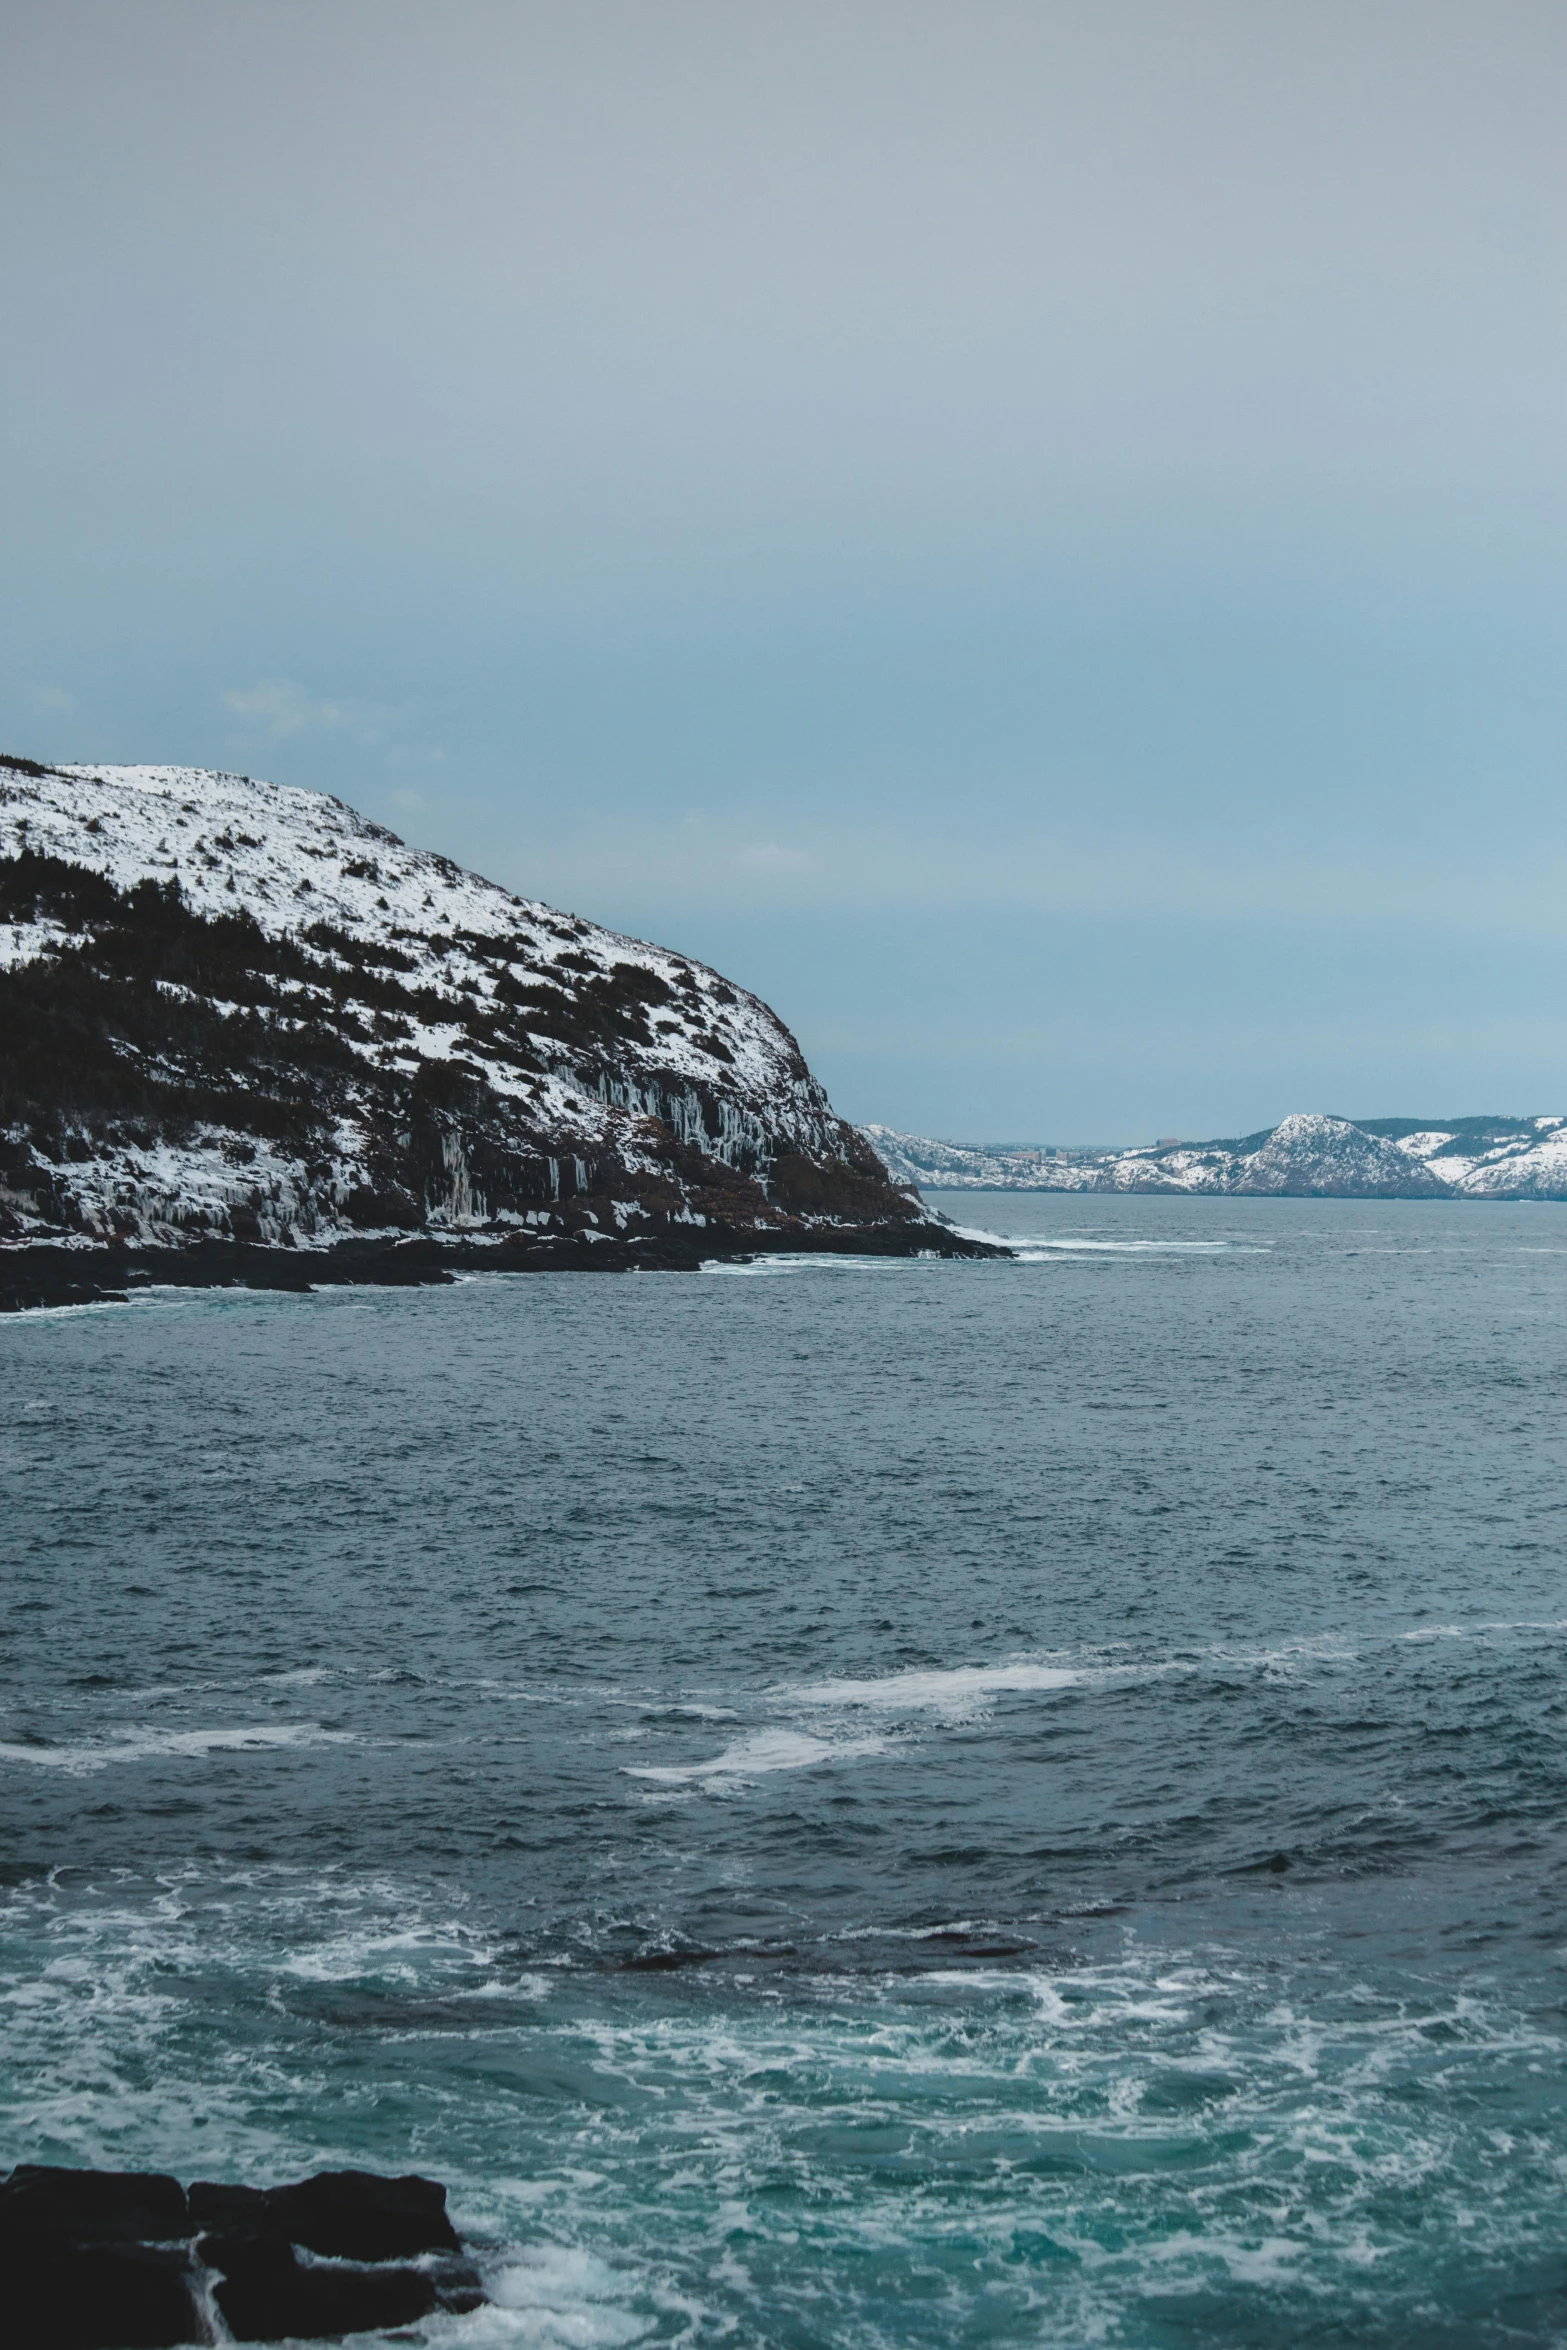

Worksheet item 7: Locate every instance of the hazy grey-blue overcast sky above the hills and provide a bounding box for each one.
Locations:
[0,0,1567,1140]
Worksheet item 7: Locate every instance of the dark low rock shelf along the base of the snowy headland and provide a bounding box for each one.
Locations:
[0,1222,1013,1314]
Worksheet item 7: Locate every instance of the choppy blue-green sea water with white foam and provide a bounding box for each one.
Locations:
[0,1196,1567,2350]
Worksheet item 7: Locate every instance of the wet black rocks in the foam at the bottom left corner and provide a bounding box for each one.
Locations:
[0,2162,489,2350]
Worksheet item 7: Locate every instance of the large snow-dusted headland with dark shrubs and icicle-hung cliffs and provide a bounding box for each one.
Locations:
[0,759,928,1248]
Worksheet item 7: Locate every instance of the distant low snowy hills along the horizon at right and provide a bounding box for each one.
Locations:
[865,1112,1567,1199]
